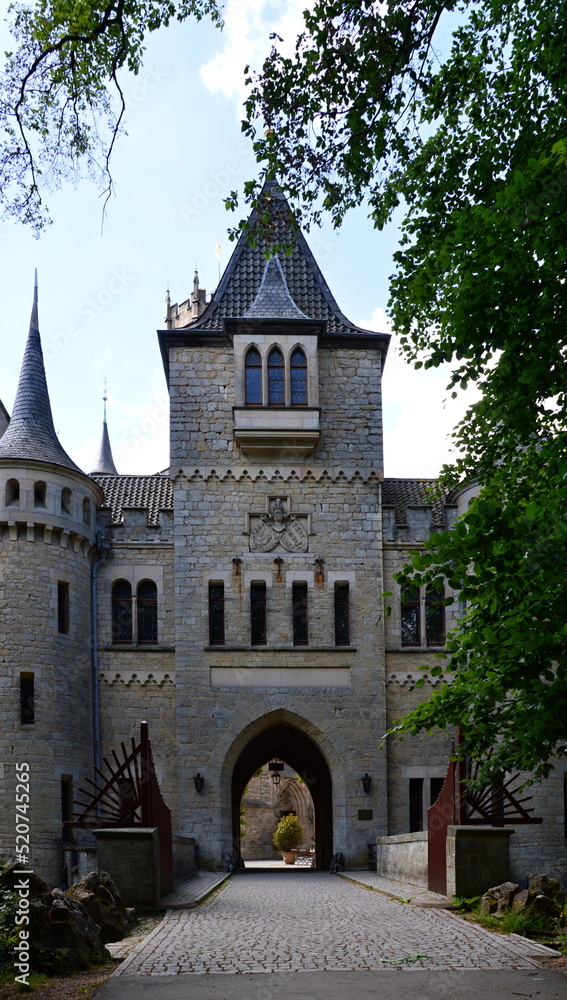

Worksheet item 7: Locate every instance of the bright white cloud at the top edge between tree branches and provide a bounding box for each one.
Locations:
[199,0,313,111]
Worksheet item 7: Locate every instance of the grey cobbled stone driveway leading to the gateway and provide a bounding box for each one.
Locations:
[113,869,549,979]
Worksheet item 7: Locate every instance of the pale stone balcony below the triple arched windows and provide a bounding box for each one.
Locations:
[233,406,320,461]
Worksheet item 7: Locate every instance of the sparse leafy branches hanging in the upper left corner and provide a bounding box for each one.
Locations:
[0,0,220,233]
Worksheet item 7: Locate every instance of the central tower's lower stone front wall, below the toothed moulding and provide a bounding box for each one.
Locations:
[171,466,386,864]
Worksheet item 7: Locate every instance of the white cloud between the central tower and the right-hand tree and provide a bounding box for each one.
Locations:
[358,308,479,479]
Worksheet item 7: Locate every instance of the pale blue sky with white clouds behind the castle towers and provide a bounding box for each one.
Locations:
[0,0,478,478]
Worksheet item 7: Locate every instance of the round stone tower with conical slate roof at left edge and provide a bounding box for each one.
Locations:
[0,285,102,885]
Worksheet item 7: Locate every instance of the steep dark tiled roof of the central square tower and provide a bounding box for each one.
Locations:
[176,181,389,341]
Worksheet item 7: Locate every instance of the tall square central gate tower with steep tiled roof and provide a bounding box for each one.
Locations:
[160,185,389,867]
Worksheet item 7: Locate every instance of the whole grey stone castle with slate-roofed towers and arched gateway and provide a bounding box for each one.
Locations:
[0,186,567,884]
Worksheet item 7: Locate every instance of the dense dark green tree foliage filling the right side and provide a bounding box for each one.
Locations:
[243,0,567,778]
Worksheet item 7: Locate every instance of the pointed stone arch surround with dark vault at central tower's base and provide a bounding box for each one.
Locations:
[221,709,339,868]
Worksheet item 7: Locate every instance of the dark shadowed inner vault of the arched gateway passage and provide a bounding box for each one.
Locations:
[232,723,333,868]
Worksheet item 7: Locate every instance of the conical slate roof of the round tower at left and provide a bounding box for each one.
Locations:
[0,279,81,472]
